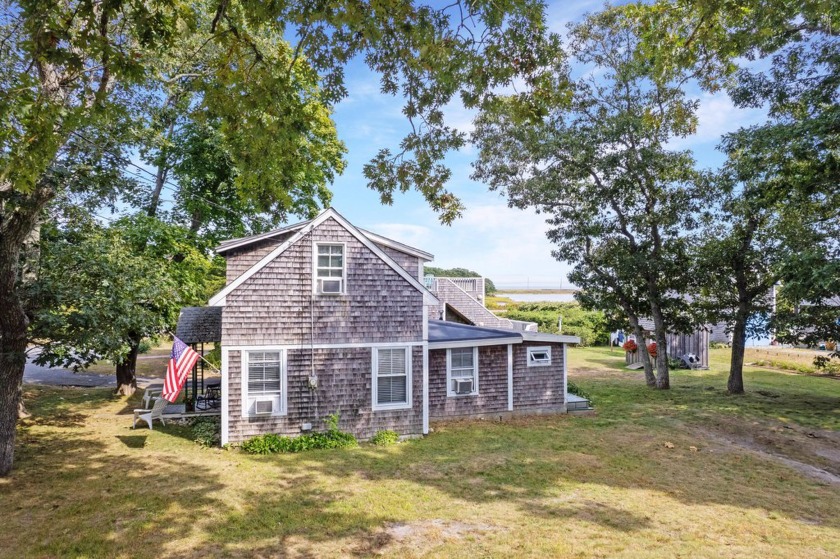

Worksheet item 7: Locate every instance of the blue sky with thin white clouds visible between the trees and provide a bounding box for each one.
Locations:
[324,1,763,288]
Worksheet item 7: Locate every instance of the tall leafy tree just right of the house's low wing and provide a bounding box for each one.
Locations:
[474,10,699,388]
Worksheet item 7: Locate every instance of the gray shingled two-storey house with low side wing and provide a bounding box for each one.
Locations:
[191,209,579,443]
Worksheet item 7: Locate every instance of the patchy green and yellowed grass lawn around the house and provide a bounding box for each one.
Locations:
[0,348,840,558]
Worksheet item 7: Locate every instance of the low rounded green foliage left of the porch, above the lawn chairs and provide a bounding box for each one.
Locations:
[29,216,217,368]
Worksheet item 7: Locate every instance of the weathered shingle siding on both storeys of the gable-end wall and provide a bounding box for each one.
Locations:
[222,219,423,442]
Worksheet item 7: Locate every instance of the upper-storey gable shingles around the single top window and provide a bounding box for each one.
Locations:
[222,219,423,347]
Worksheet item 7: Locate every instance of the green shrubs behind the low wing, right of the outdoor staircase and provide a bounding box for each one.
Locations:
[504,302,610,346]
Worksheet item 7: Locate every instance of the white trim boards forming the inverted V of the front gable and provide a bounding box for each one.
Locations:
[208,208,440,306]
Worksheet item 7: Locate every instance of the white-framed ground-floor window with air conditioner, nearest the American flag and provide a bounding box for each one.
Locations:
[242,350,286,416]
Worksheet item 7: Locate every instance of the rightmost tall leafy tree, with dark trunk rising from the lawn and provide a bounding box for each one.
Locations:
[624,0,840,376]
